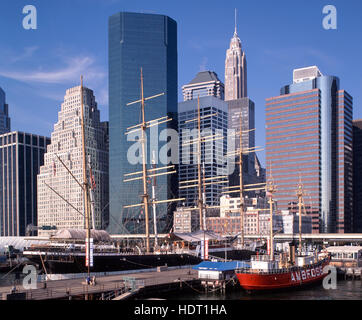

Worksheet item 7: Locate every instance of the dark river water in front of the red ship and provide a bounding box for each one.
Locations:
[159,280,362,300]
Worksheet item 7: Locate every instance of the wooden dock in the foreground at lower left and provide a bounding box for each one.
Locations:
[0,267,200,300]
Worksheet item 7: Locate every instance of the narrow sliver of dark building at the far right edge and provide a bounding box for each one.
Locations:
[353,119,362,233]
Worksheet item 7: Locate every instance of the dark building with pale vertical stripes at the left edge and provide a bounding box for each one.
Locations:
[0,131,50,237]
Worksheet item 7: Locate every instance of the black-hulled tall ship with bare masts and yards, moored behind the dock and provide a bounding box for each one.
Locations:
[23,69,255,276]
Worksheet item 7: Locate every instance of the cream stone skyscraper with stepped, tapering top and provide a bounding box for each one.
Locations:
[38,86,108,234]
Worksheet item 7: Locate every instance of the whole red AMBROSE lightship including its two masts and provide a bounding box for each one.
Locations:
[235,179,330,292]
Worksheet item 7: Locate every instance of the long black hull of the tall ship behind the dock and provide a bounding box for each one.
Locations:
[27,250,252,274]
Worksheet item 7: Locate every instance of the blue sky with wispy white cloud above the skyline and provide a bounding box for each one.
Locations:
[0,0,362,162]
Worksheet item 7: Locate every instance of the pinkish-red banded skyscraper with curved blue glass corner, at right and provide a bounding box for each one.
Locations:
[266,66,352,233]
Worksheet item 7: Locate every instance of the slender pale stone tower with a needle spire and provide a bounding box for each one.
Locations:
[225,10,248,101]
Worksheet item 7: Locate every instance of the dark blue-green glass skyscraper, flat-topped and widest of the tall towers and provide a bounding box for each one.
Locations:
[109,12,178,233]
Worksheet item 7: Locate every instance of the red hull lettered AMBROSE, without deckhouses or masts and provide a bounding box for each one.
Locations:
[235,259,329,291]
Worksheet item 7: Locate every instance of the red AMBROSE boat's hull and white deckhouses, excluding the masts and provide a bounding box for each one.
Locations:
[235,256,330,291]
